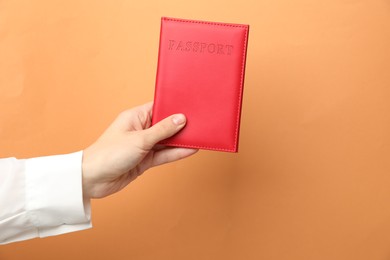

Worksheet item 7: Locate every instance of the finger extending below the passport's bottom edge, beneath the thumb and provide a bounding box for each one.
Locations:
[151,148,198,167]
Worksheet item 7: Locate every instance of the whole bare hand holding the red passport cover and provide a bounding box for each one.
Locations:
[82,103,197,199]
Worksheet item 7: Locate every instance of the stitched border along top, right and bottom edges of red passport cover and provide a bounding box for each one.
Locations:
[162,17,248,151]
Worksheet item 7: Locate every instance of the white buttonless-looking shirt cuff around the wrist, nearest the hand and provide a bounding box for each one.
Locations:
[25,151,92,237]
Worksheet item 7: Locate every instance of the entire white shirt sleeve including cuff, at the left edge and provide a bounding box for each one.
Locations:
[0,151,92,244]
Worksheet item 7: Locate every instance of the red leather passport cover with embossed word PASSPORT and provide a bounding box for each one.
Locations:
[152,17,249,152]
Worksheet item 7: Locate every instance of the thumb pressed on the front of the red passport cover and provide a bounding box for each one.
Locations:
[144,114,186,149]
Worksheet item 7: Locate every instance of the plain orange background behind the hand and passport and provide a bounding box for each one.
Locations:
[0,0,390,260]
